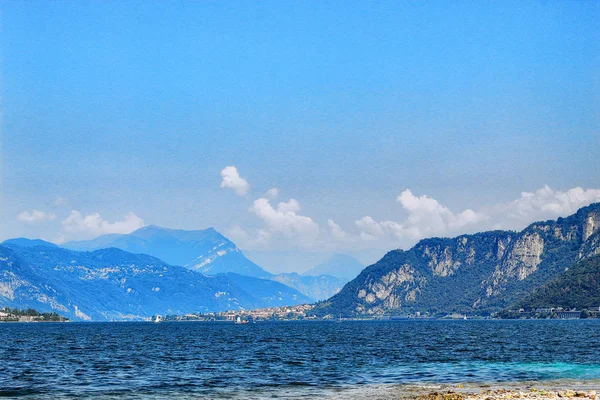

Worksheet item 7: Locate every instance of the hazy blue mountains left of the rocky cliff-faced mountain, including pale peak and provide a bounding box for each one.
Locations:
[0,225,346,320]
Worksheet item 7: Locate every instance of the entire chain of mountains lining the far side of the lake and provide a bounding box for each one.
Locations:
[0,203,600,320]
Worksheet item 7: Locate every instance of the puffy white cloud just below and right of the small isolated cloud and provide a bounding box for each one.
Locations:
[250,197,319,245]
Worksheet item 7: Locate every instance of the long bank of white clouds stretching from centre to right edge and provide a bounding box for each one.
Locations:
[227,170,600,250]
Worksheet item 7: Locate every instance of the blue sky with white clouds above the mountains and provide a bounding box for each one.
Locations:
[0,0,600,266]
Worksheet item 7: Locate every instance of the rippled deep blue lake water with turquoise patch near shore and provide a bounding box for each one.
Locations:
[0,320,600,399]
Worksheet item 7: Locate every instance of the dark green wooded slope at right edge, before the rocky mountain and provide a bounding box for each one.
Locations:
[511,255,600,310]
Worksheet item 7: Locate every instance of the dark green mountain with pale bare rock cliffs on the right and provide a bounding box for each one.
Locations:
[318,203,600,315]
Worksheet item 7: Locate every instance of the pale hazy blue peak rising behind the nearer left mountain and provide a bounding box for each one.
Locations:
[62,225,272,278]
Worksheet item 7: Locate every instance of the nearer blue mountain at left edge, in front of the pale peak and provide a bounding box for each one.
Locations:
[0,244,308,320]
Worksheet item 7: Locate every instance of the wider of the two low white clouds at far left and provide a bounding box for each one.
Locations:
[62,210,145,239]
